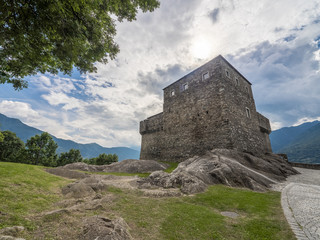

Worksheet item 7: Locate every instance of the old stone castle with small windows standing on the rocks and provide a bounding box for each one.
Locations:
[140,55,272,161]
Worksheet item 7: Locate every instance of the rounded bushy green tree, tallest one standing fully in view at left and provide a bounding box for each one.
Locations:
[26,132,58,167]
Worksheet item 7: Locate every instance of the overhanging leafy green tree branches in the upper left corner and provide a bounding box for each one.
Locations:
[0,0,160,90]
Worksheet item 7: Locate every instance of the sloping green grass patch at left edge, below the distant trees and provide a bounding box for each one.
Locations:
[0,162,70,229]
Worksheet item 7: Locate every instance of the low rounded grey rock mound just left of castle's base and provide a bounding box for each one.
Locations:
[104,159,167,173]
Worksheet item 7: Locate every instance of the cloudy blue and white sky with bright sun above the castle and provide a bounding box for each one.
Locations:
[0,0,320,149]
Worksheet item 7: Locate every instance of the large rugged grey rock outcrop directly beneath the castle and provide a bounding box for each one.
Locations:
[139,149,298,194]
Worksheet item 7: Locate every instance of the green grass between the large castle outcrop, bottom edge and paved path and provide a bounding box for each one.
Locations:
[107,185,295,240]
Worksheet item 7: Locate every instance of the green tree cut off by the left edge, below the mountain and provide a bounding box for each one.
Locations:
[0,131,24,162]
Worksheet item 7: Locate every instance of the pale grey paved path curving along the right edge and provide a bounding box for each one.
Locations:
[274,168,320,240]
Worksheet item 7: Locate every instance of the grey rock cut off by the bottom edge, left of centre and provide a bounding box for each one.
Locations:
[79,216,132,240]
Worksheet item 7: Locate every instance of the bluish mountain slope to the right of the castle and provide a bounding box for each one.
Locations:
[270,121,320,164]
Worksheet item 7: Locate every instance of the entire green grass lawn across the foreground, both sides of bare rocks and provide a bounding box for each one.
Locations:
[0,162,295,240]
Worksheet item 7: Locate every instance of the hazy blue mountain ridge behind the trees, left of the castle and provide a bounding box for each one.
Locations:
[0,113,140,161]
